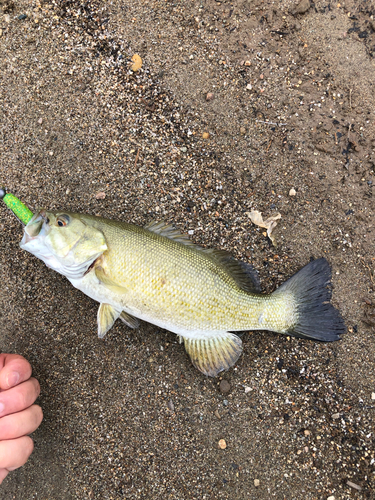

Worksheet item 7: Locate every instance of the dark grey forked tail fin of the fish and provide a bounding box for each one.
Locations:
[274,258,346,342]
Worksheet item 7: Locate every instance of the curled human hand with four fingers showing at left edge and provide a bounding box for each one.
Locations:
[0,353,43,484]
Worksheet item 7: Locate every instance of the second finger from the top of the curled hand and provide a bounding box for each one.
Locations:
[0,377,40,417]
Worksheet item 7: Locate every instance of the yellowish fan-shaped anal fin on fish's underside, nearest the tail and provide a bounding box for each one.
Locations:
[184,332,242,377]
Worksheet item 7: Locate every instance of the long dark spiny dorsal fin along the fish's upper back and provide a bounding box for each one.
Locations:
[144,221,261,293]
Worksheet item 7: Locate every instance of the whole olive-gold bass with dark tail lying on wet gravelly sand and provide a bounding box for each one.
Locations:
[20,210,346,377]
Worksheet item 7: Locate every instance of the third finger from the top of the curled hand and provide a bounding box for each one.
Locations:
[0,405,43,440]
